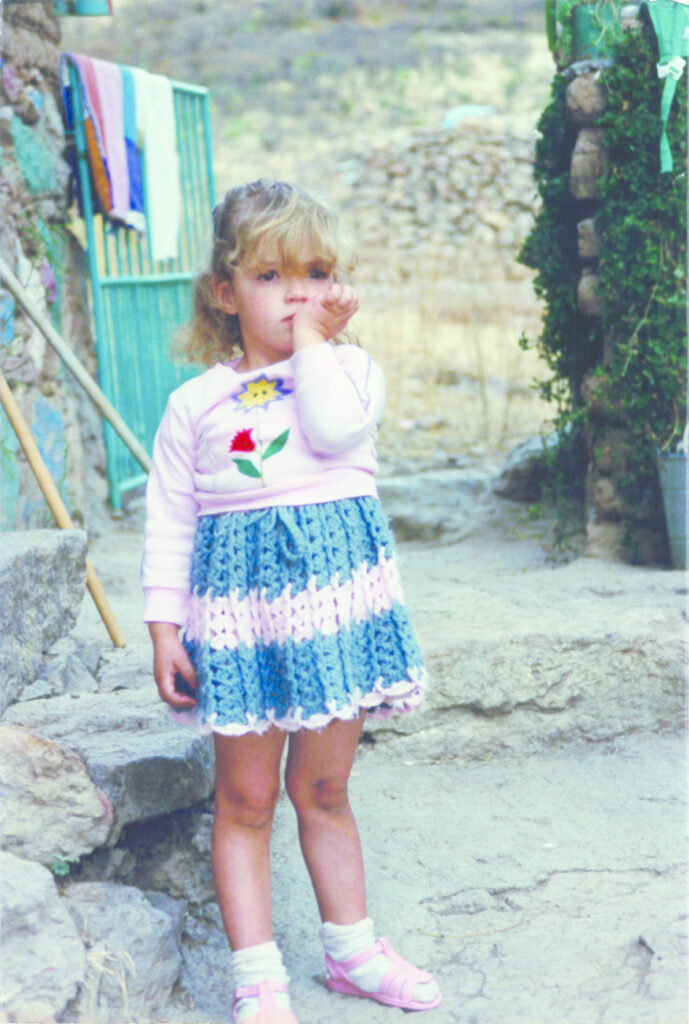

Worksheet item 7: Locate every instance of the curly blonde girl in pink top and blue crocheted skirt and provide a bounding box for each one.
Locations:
[143,180,441,1024]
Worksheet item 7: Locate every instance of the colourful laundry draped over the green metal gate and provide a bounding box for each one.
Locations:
[60,53,181,261]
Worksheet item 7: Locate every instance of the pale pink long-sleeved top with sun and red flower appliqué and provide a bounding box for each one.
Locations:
[141,342,385,626]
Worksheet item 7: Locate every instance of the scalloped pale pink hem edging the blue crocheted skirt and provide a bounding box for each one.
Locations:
[170,669,428,736]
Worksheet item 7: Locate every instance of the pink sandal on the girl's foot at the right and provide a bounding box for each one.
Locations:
[326,939,442,1010]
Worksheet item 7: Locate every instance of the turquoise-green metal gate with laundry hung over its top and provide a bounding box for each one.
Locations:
[70,67,215,509]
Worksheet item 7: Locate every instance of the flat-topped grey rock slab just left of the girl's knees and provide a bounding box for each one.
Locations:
[5,686,214,843]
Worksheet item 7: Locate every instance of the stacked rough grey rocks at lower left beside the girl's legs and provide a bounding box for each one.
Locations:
[0,529,214,1024]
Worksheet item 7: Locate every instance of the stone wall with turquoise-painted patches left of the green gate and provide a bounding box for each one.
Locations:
[0,3,106,529]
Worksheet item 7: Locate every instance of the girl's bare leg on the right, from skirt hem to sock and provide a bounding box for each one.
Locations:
[285,716,367,925]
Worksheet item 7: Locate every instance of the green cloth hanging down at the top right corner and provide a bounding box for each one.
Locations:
[645,0,689,173]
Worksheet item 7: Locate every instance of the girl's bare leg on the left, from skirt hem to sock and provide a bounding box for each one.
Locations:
[212,729,287,950]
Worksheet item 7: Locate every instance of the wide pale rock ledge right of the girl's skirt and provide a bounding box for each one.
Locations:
[367,545,686,760]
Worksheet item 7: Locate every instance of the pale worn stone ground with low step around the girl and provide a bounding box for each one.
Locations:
[76,484,689,1024]
